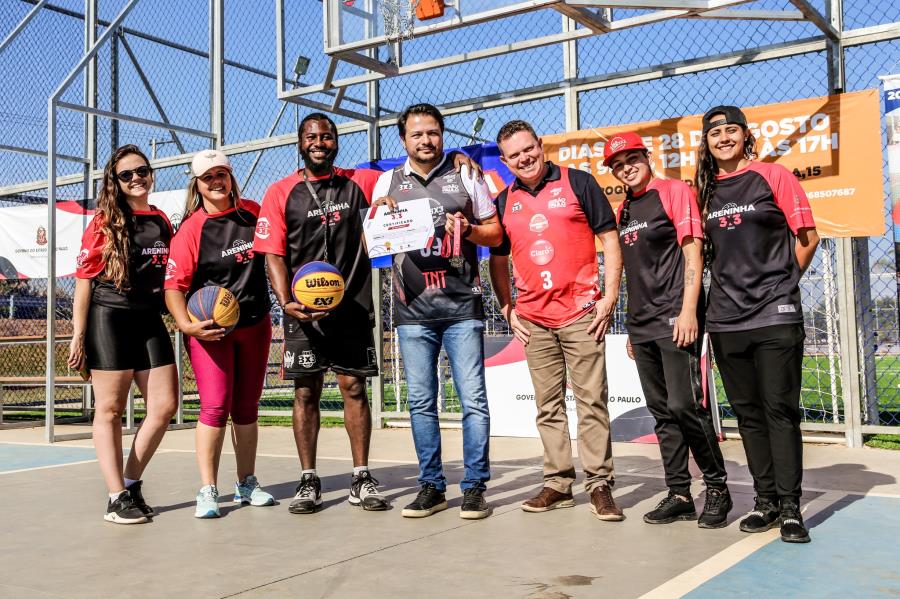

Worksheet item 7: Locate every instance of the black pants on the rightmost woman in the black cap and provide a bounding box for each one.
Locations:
[710,323,805,499]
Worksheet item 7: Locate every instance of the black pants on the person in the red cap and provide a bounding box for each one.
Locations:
[632,338,728,495]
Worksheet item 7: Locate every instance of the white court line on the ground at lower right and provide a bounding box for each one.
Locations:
[639,491,846,599]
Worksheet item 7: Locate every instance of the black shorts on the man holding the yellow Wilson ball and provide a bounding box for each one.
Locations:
[281,314,378,380]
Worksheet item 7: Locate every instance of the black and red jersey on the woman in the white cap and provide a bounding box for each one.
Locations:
[165,200,270,327]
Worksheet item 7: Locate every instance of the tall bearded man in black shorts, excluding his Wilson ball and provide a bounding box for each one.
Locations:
[253,113,387,514]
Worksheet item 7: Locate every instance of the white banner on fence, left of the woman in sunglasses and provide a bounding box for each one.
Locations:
[0,202,93,279]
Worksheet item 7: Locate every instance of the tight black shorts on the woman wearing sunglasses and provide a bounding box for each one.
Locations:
[84,302,175,371]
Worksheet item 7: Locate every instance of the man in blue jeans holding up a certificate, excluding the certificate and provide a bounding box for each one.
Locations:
[372,104,502,519]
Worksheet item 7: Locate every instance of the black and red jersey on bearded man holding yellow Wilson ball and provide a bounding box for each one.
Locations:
[253,168,381,318]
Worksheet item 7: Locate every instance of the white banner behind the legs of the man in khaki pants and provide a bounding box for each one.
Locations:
[485,335,656,442]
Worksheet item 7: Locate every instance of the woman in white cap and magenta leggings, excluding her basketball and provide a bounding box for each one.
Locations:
[165,150,275,518]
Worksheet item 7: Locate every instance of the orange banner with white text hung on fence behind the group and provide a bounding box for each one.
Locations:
[543,89,886,237]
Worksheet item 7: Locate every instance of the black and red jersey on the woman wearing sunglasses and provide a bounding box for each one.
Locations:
[75,206,173,310]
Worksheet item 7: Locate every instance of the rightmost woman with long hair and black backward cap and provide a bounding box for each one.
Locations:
[695,106,819,543]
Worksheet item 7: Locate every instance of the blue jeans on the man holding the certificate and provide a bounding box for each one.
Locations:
[397,320,491,493]
